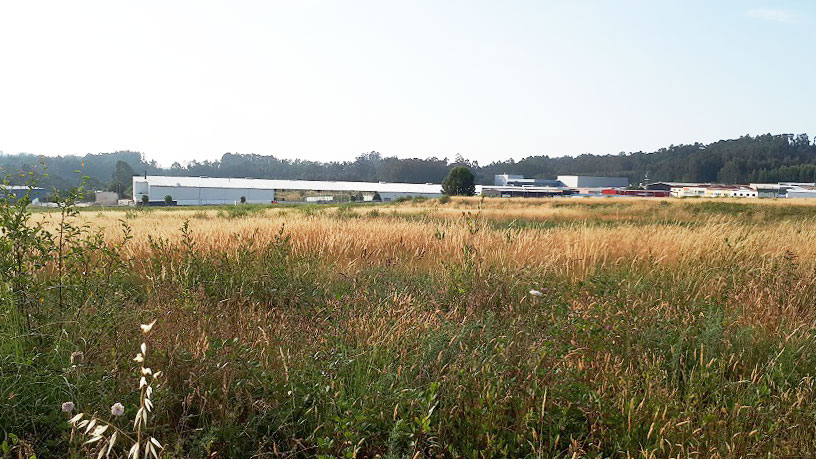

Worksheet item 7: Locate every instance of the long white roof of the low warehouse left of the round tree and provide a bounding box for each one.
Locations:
[141,175,442,194]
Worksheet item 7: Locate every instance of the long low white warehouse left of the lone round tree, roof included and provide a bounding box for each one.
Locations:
[133,175,442,206]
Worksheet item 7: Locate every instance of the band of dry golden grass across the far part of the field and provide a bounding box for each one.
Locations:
[35,198,816,278]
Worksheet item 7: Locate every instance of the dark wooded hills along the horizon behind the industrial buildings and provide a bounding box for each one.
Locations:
[0,134,816,196]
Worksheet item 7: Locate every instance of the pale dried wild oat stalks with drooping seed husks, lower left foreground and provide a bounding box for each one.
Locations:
[67,320,163,459]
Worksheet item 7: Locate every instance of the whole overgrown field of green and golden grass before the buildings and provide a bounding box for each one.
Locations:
[0,198,816,458]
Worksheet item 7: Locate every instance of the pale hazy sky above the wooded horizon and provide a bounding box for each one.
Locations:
[0,0,816,166]
